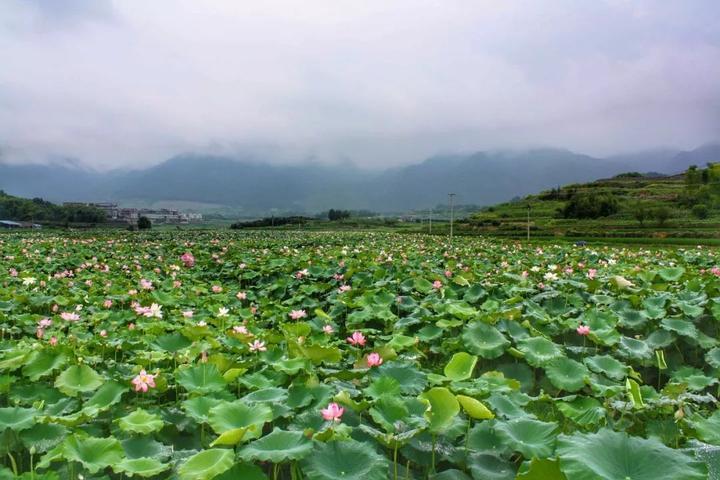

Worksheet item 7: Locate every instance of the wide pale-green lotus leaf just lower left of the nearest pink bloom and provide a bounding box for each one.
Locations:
[238,428,313,463]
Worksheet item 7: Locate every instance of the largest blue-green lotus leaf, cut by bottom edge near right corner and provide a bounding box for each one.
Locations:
[557,428,707,480]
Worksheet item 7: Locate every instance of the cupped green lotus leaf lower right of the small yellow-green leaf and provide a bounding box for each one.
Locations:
[495,417,559,460]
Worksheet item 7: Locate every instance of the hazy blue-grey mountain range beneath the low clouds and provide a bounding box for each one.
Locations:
[0,144,720,215]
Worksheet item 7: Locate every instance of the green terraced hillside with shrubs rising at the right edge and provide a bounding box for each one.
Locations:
[464,164,720,239]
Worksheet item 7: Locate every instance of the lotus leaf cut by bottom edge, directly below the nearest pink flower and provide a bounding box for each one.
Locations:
[303,440,389,480]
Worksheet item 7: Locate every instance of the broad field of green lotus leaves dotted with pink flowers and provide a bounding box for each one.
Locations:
[0,231,720,480]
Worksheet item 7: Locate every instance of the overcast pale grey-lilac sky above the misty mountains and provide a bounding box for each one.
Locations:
[0,0,720,168]
